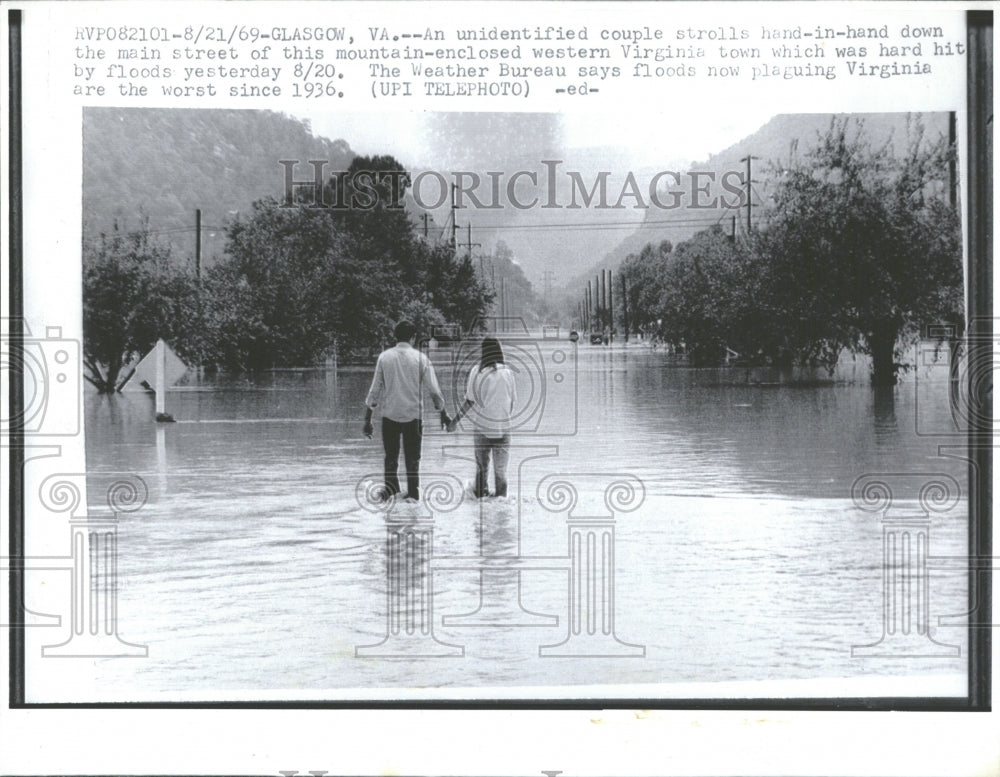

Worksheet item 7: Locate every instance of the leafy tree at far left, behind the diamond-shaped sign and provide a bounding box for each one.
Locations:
[83,225,201,394]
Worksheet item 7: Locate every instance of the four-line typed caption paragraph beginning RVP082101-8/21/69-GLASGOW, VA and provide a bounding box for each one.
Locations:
[72,14,966,101]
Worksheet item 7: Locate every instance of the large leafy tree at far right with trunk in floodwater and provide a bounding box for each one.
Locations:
[760,119,962,385]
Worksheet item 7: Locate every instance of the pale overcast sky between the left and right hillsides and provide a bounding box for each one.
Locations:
[298,104,772,284]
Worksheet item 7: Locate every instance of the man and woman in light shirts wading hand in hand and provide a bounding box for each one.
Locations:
[364,321,517,500]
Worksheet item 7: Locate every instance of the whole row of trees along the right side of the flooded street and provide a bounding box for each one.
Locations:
[615,118,964,385]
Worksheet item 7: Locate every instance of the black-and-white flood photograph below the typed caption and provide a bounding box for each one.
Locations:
[53,109,974,701]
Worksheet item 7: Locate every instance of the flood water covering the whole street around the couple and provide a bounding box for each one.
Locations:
[45,341,967,701]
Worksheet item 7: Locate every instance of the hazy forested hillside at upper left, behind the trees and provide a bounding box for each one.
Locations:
[83,108,355,266]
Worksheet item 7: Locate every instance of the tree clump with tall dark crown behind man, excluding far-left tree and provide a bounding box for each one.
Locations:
[206,157,490,369]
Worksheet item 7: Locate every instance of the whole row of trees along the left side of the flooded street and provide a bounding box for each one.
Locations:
[83,156,493,392]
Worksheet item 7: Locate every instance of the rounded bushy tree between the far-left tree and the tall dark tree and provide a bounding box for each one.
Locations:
[216,199,407,369]
